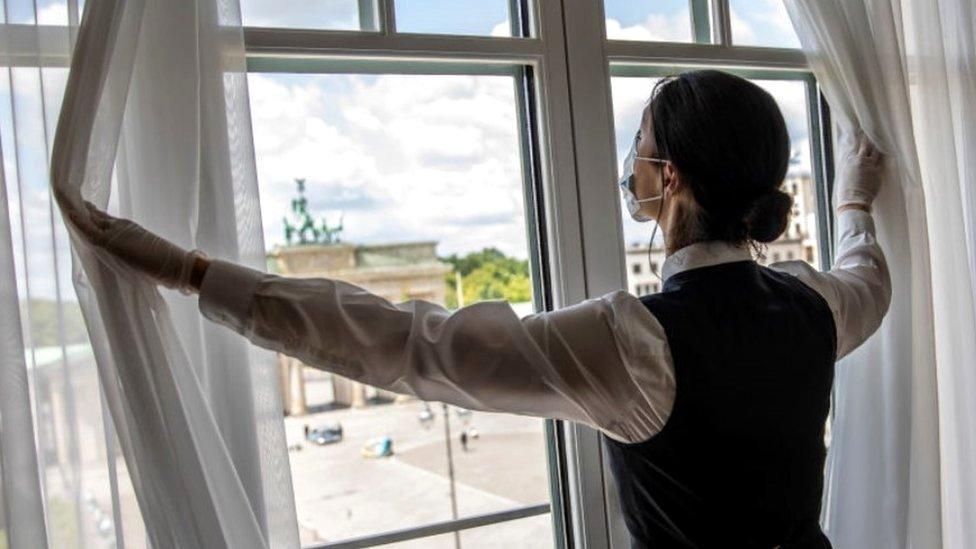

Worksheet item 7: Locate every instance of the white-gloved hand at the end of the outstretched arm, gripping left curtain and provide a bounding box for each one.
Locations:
[70,202,205,293]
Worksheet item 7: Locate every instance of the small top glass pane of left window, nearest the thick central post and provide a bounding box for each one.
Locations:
[396,0,512,36]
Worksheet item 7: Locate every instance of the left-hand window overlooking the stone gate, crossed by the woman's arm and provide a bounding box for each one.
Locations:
[245,0,561,547]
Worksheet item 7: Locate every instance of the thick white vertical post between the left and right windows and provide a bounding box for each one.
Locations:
[549,0,626,549]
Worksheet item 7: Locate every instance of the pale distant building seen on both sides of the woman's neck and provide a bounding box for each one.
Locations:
[626,171,820,295]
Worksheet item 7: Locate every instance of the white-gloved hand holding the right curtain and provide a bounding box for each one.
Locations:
[833,133,884,210]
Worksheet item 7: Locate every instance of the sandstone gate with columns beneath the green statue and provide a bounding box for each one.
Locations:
[268,241,452,415]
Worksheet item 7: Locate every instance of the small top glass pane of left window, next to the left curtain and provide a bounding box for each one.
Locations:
[241,0,373,30]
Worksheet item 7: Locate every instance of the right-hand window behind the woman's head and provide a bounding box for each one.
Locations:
[566,0,829,546]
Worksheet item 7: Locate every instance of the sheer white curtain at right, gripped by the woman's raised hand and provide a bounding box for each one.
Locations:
[786,0,976,549]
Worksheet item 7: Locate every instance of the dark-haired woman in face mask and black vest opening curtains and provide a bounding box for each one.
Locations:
[73,71,890,548]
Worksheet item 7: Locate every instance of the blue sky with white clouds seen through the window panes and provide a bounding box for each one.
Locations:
[245,0,809,258]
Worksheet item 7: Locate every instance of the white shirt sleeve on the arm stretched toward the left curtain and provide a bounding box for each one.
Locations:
[194,261,675,442]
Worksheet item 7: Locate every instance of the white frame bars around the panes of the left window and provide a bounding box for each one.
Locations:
[244,0,584,549]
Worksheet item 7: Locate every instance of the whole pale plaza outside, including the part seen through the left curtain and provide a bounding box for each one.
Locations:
[44,356,552,549]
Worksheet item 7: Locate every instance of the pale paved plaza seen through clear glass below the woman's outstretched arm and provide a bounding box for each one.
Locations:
[285,374,552,548]
